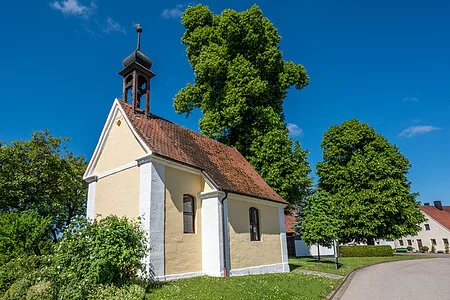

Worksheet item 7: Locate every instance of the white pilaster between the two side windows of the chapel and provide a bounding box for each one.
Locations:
[200,191,228,277]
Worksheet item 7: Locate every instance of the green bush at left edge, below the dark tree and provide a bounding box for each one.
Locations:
[0,211,51,266]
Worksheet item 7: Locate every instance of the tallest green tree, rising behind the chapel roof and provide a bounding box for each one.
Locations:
[174,5,311,203]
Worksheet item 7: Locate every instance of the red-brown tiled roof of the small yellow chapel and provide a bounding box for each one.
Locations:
[118,101,287,203]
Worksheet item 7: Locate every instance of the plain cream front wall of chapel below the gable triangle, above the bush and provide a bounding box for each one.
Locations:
[94,166,140,219]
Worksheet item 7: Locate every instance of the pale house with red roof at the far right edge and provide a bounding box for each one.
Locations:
[395,201,450,251]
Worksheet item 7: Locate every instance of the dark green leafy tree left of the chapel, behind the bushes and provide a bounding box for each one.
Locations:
[0,131,86,241]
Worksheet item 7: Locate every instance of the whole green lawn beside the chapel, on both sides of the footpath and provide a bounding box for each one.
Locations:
[147,255,427,300]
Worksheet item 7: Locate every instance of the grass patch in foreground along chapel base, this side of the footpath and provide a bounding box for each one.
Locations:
[147,272,340,299]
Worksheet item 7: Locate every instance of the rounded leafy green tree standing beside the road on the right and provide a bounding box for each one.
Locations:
[317,119,425,244]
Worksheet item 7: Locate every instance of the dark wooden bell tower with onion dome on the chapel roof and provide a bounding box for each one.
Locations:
[119,24,155,118]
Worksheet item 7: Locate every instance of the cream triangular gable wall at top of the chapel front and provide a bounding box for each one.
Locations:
[92,110,146,175]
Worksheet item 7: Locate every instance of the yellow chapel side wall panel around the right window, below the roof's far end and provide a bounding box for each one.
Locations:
[228,196,282,270]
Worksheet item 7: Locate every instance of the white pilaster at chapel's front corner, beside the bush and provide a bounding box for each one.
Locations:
[138,157,165,278]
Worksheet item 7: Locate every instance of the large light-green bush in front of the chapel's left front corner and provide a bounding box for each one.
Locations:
[50,216,147,299]
